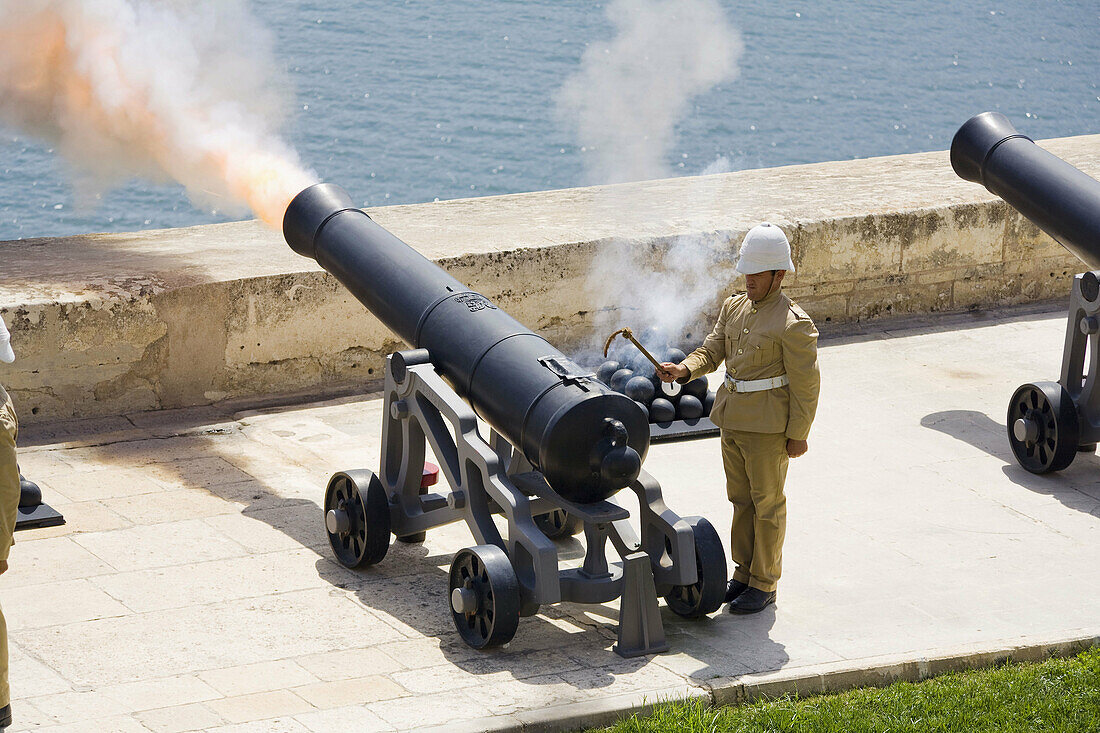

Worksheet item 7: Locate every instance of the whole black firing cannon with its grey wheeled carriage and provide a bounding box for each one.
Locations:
[283,184,726,656]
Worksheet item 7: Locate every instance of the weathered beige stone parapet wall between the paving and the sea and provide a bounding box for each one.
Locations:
[0,135,1082,422]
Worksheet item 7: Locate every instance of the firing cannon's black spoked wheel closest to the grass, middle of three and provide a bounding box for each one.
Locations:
[448,545,520,649]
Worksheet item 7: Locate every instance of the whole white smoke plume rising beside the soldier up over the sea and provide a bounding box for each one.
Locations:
[558,0,744,371]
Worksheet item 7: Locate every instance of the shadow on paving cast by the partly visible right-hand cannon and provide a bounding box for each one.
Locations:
[921,409,1100,514]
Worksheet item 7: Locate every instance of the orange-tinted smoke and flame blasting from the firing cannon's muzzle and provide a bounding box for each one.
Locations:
[0,0,317,229]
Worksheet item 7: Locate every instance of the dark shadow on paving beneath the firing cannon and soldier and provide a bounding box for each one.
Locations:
[301,519,790,690]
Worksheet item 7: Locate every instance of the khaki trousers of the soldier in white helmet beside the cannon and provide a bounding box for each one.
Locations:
[722,430,790,592]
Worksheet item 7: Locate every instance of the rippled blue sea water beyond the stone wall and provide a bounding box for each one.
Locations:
[0,0,1100,240]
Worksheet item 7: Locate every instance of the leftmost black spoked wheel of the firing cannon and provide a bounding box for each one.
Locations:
[322,469,389,568]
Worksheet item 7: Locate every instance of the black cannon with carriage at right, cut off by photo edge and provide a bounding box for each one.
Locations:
[952,112,1100,473]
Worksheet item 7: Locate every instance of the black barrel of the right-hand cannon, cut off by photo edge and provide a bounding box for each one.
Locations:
[952,112,1100,270]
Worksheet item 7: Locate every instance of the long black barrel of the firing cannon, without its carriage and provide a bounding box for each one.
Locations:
[283,184,649,503]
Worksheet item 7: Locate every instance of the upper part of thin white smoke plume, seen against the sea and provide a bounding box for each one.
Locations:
[557,0,744,184]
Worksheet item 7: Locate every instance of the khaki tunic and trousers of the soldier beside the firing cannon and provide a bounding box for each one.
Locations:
[681,291,821,592]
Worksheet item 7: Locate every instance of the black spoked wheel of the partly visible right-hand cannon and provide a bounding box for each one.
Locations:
[1007,382,1080,473]
